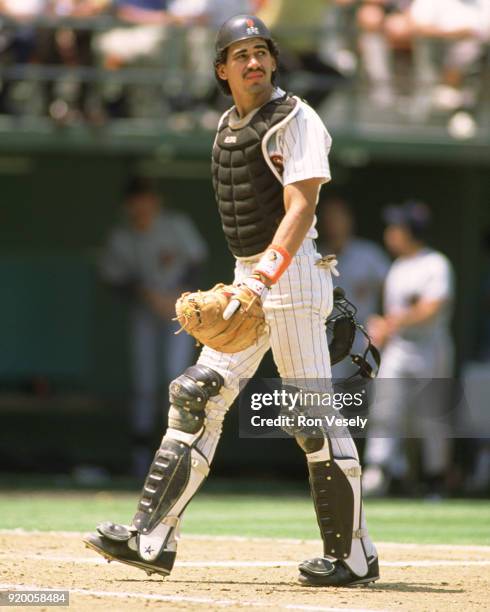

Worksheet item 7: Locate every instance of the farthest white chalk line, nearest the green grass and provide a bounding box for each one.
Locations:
[0,528,490,552]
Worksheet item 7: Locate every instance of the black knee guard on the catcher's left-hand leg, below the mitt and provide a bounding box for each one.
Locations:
[168,364,224,433]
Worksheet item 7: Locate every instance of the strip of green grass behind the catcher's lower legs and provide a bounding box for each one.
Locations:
[0,482,490,545]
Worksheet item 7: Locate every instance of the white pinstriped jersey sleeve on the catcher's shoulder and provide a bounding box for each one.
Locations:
[278,102,332,186]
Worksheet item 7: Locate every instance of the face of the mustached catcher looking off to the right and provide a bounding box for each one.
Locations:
[218,38,276,95]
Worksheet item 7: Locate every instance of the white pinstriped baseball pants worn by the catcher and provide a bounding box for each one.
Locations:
[196,239,358,463]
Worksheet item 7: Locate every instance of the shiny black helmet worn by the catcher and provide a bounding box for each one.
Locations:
[214,15,279,95]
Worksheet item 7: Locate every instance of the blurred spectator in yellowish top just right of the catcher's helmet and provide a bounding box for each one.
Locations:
[258,0,343,106]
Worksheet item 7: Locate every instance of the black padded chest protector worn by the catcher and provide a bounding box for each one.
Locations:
[212,95,298,257]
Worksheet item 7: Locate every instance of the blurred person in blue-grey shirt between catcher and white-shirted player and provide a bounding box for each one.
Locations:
[318,197,390,378]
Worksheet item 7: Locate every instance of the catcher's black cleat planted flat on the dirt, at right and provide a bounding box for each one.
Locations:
[298,557,379,587]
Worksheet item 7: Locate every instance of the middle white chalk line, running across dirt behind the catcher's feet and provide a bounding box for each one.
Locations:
[0,553,490,568]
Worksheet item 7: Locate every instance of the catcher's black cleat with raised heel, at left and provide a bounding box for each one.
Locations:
[83,523,176,576]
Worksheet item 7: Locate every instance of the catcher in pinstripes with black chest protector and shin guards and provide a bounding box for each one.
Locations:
[86,15,379,586]
